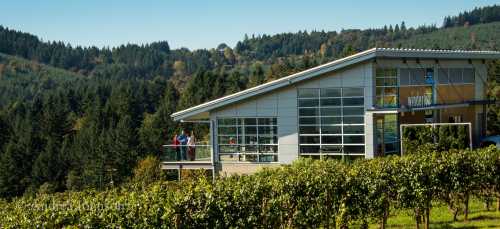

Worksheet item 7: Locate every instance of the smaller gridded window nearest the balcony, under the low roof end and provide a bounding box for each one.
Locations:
[217,117,278,162]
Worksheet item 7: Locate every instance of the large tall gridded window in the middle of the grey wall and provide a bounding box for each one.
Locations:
[298,87,366,157]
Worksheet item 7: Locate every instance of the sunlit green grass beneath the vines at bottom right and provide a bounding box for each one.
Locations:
[370,199,500,229]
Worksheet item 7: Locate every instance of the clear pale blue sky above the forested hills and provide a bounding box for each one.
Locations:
[0,0,500,49]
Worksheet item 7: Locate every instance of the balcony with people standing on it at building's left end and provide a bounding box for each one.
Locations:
[160,144,213,169]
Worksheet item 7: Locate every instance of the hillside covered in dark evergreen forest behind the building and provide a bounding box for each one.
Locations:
[0,6,500,197]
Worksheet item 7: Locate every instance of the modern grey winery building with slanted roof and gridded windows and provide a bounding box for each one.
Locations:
[163,48,500,173]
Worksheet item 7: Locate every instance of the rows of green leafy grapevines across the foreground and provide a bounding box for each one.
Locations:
[0,147,500,228]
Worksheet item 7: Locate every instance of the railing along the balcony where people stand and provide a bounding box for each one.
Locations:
[160,145,212,163]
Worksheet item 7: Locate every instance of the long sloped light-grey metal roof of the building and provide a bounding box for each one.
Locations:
[171,48,500,121]
